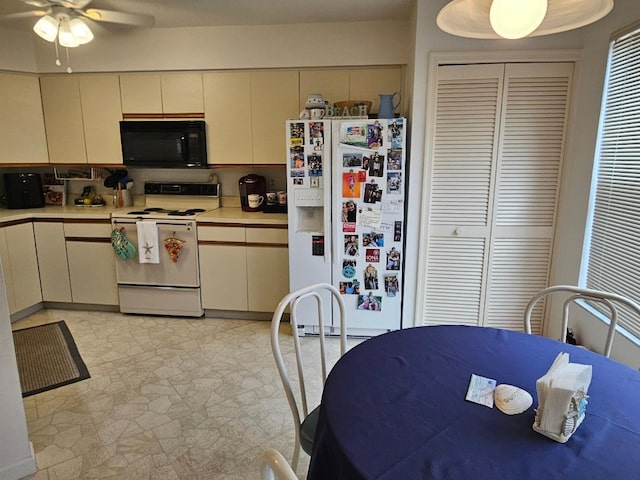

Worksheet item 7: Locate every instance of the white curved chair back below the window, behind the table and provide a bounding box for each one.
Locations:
[524,285,640,357]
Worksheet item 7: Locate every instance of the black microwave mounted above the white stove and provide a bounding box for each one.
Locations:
[120,120,207,168]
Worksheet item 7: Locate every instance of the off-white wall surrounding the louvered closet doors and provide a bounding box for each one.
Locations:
[405,0,640,366]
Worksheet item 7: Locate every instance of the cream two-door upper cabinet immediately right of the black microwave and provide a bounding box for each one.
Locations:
[204,70,299,165]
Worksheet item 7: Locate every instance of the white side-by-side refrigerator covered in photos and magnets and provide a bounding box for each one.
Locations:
[286,118,406,336]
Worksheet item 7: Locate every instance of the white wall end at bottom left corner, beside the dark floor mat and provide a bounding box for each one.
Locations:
[0,266,36,480]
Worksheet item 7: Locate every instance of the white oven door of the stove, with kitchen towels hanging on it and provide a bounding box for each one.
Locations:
[112,219,200,287]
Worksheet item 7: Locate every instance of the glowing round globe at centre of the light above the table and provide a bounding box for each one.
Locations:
[489,0,548,39]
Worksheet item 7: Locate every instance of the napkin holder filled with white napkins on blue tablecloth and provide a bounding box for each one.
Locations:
[533,353,592,443]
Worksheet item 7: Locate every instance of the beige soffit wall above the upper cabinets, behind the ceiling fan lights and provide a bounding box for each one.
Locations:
[26,21,408,72]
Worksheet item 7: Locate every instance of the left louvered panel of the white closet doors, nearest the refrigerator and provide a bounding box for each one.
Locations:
[423,65,504,325]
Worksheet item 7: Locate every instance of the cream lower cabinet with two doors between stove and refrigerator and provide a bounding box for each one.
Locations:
[198,224,289,312]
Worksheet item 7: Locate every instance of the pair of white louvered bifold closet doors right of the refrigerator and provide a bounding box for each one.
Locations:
[423,64,573,333]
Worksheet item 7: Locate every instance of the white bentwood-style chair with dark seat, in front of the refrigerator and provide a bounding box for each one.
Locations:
[271,283,347,469]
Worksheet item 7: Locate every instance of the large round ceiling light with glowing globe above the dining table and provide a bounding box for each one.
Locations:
[436,0,613,39]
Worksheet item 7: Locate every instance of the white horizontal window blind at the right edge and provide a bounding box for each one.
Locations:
[584,29,640,340]
